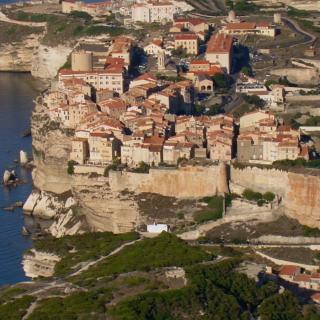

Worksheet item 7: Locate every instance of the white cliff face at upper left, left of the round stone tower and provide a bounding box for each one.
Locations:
[31,44,72,79]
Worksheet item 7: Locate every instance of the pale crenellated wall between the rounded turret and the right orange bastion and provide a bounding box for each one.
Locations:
[230,166,288,197]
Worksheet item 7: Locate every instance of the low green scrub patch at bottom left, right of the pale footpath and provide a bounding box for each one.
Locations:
[27,289,112,320]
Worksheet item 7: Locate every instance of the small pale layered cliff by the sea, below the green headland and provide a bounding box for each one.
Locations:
[22,249,61,278]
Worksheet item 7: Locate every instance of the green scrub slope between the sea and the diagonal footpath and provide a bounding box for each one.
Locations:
[34,232,139,276]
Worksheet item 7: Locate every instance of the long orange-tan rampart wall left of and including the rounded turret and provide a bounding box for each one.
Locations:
[109,165,228,198]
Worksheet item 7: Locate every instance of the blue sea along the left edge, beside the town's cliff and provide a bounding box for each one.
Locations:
[0,73,37,287]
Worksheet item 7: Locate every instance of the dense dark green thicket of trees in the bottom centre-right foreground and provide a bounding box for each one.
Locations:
[109,259,277,320]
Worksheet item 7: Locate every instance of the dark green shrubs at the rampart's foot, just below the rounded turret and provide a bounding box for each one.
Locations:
[194,196,223,223]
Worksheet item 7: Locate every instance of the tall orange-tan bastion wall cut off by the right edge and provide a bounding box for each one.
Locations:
[285,172,320,228]
